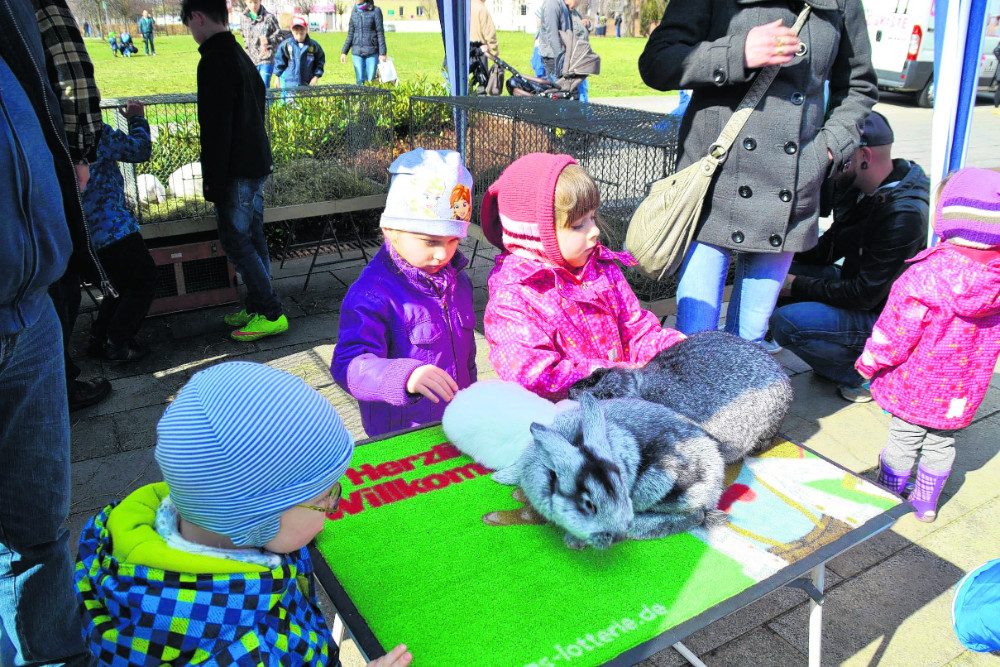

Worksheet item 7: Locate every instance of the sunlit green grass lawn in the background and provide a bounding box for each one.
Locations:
[87,32,658,97]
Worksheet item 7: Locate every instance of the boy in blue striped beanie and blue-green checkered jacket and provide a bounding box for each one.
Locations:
[76,361,411,667]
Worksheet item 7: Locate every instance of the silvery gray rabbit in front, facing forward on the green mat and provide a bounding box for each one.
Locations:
[493,394,727,549]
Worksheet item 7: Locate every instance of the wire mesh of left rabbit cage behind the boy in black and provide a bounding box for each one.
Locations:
[101,85,394,230]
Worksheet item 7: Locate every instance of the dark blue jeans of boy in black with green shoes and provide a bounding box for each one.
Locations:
[215,176,281,320]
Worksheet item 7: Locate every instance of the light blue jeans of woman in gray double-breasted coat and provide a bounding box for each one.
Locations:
[677,241,793,342]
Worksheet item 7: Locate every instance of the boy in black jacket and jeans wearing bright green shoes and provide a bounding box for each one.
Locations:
[181,0,288,341]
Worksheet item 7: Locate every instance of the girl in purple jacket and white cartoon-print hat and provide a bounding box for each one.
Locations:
[330,148,476,436]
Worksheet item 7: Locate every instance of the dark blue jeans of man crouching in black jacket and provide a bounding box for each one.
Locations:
[771,263,879,387]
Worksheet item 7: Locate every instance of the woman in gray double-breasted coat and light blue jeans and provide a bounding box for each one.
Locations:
[639,0,878,342]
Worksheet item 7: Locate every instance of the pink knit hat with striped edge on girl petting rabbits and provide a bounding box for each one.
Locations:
[480,153,576,264]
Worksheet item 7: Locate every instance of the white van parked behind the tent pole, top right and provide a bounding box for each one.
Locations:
[864,0,1000,107]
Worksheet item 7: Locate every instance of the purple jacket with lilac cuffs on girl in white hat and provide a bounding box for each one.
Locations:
[330,246,476,437]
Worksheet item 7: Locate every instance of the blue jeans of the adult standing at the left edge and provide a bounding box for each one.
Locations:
[0,297,96,666]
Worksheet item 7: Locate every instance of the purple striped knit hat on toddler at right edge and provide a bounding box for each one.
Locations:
[934,167,1000,248]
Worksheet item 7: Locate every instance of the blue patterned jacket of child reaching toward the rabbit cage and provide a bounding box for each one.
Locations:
[83,116,153,250]
